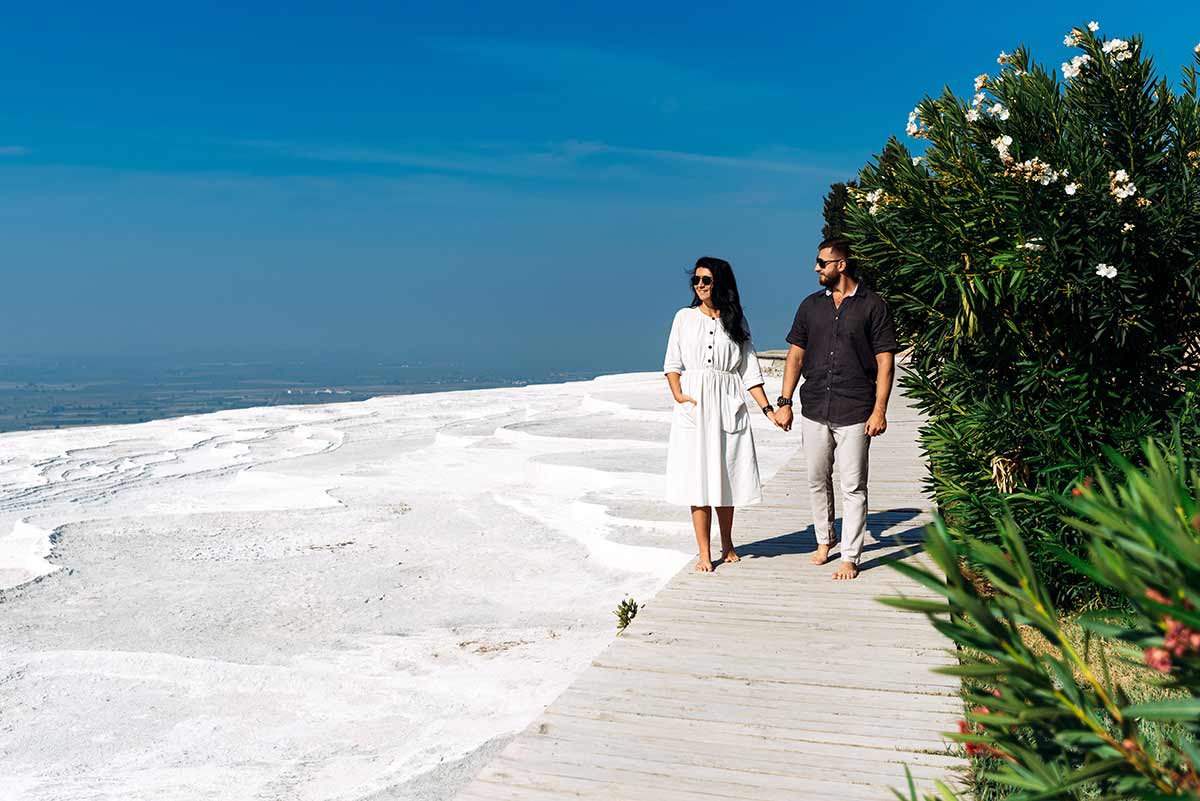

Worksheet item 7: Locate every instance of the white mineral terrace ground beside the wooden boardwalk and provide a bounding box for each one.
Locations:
[0,374,798,801]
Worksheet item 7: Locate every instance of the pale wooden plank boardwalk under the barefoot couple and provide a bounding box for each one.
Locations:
[457,396,965,801]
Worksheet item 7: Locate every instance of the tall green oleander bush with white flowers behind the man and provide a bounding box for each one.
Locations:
[830,25,1200,609]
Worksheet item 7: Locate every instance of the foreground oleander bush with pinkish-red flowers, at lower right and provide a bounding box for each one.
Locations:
[883,438,1200,801]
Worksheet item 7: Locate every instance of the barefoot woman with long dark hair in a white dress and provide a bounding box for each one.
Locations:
[662,257,775,573]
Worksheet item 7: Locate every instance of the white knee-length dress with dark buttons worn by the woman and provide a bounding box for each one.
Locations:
[662,307,762,506]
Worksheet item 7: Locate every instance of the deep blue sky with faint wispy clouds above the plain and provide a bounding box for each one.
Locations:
[0,2,1200,369]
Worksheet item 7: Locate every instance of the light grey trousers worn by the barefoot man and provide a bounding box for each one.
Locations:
[800,415,871,565]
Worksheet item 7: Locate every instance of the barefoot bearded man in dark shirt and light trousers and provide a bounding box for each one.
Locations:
[775,239,899,579]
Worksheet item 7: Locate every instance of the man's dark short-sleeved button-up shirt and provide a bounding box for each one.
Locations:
[787,284,900,426]
